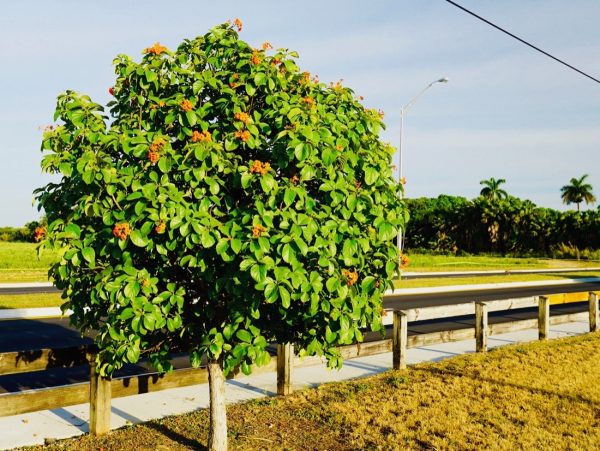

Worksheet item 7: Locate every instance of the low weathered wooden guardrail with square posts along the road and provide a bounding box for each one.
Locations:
[0,292,600,435]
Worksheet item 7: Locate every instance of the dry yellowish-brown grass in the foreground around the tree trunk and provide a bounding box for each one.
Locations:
[27,333,600,451]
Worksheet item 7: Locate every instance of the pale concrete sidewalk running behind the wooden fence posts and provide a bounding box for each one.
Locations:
[0,322,589,449]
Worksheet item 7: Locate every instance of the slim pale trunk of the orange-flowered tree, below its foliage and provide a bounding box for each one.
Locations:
[208,359,227,451]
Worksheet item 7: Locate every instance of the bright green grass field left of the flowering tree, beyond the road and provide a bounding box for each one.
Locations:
[0,242,56,283]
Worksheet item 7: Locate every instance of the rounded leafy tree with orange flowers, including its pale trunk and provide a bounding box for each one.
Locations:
[36,20,406,449]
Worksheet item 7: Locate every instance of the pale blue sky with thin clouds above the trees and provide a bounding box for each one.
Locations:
[0,0,600,226]
